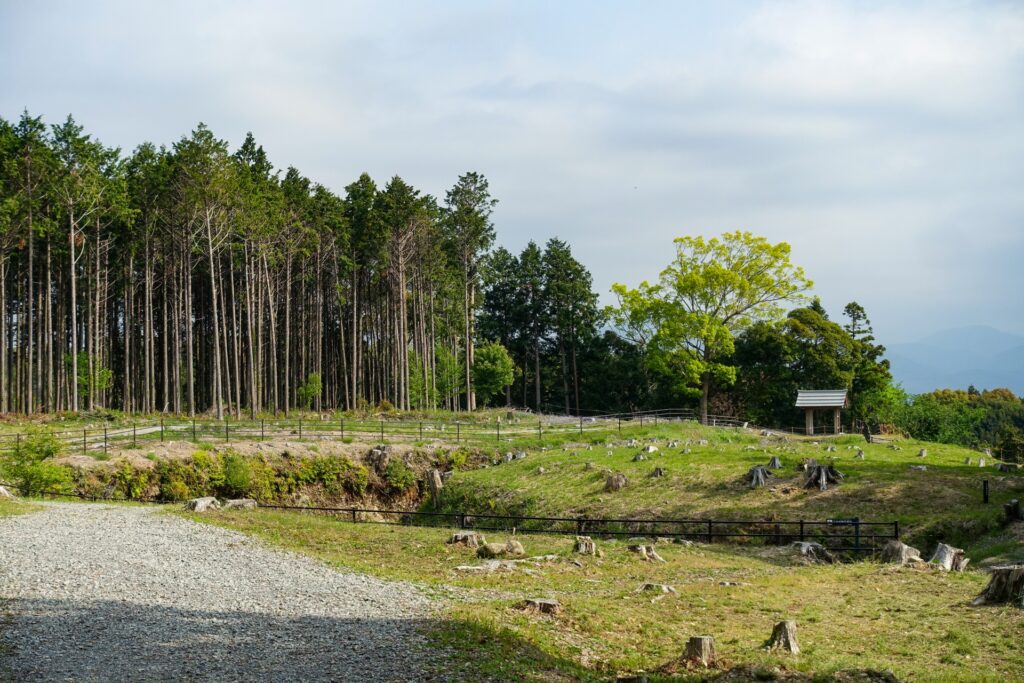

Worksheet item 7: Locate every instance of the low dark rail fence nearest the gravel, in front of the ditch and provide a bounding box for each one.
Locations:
[0,482,900,554]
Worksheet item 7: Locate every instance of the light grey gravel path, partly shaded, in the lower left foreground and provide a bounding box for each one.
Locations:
[0,504,431,681]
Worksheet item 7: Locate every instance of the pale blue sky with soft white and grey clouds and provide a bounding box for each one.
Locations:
[0,0,1024,342]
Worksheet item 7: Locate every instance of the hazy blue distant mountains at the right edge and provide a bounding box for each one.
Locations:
[886,326,1024,396]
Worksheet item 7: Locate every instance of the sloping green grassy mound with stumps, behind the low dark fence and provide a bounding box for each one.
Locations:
[443,423,1024,557]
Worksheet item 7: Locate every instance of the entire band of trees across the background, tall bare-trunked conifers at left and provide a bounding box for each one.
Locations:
[0,113,1024,454]
